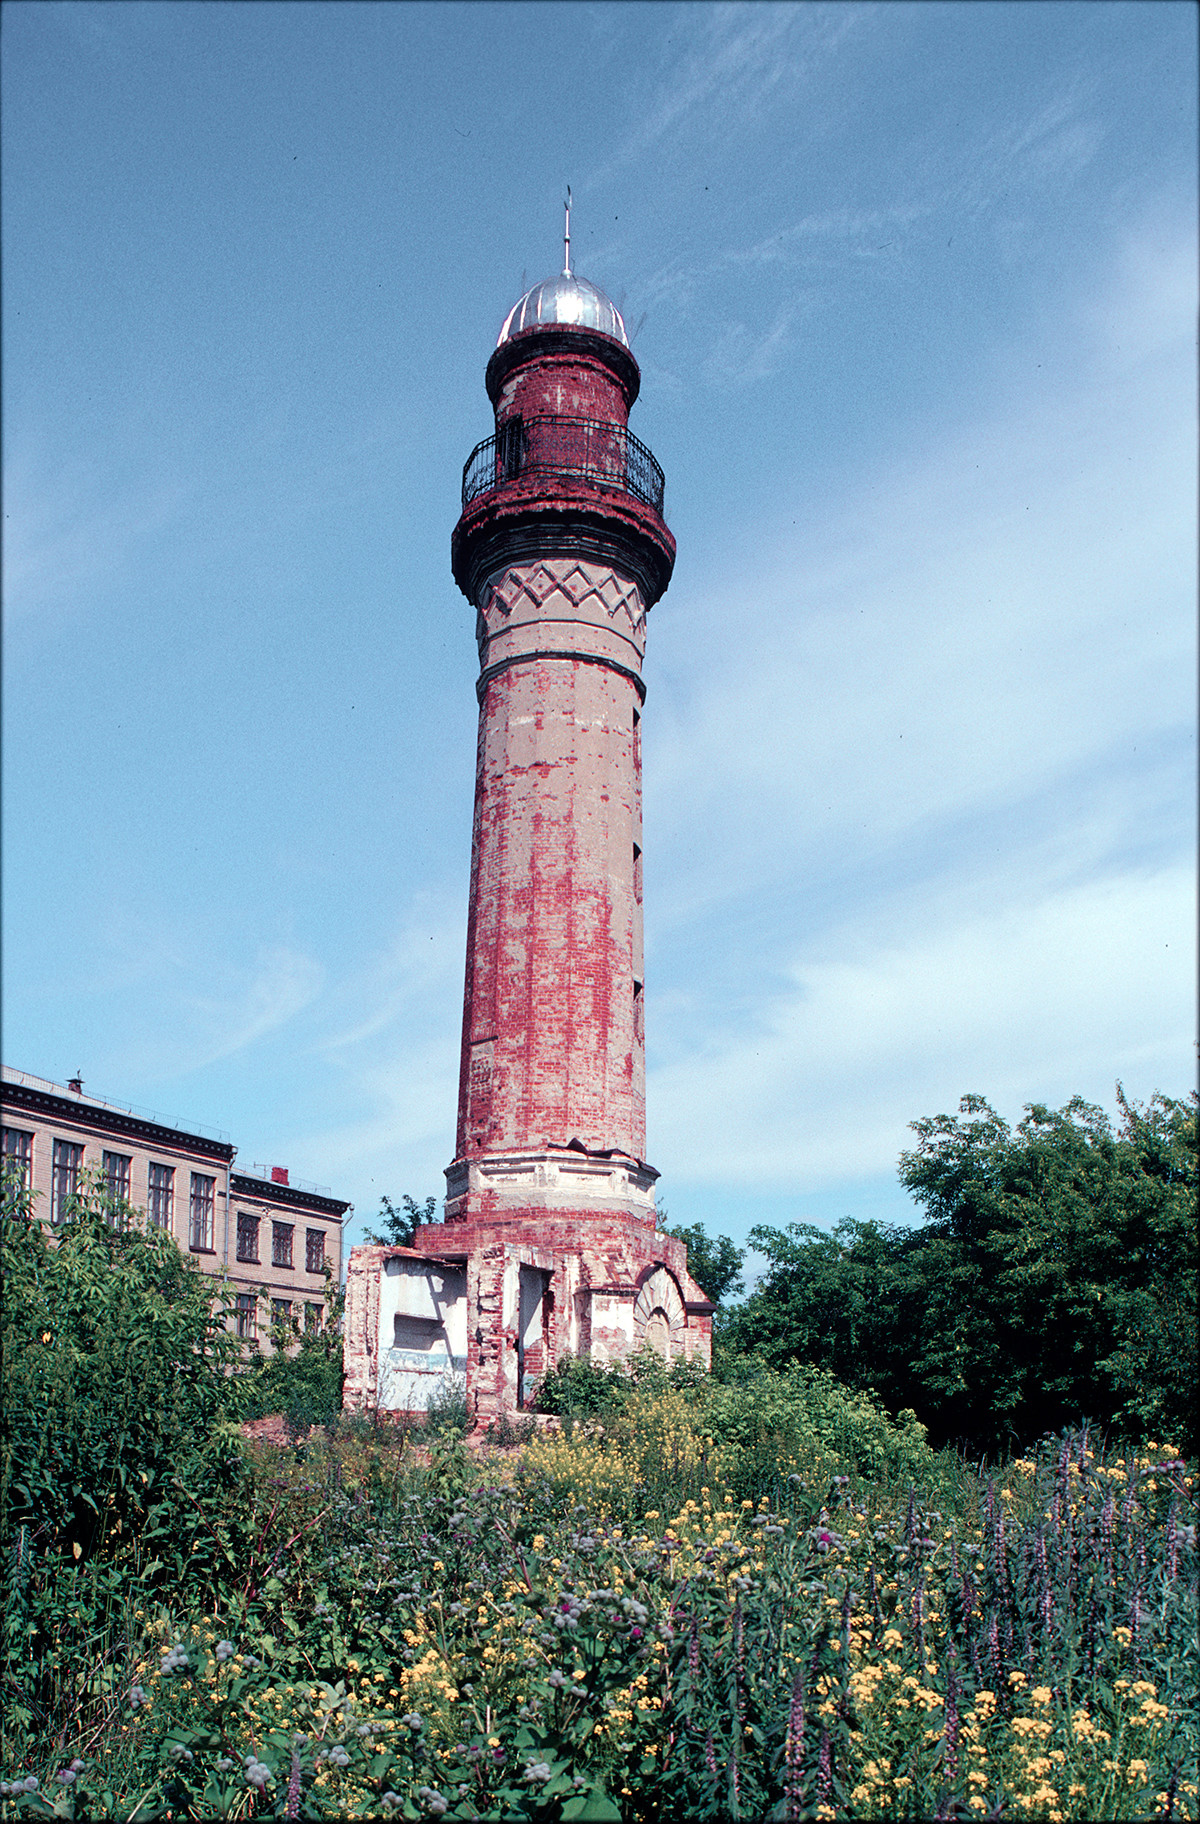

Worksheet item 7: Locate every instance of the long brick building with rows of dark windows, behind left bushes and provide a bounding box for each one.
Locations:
[0,1065,352,1346]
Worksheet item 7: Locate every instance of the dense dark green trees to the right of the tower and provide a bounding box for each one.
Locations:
[726,1089,1196,1452]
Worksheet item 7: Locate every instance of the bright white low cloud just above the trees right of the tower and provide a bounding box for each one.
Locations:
[649,866,1195,1191]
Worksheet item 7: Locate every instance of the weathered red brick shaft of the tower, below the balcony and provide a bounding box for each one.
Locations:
[458,605,646,1158]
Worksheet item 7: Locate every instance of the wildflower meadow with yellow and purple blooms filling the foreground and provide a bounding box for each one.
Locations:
[0,1422,1200,1824]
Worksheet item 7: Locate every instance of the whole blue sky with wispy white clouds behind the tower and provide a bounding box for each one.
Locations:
[2,0,1196,1269]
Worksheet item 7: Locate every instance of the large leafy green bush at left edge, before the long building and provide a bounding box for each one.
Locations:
[0,1178,237,1560]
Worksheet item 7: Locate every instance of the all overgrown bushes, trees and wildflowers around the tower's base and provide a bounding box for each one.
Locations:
[0,1098,1200,1824]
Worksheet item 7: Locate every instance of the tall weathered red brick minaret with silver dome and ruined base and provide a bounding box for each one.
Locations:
[345,241,713,1423]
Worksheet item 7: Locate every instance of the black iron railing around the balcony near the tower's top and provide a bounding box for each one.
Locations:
[463,418,666,514]
